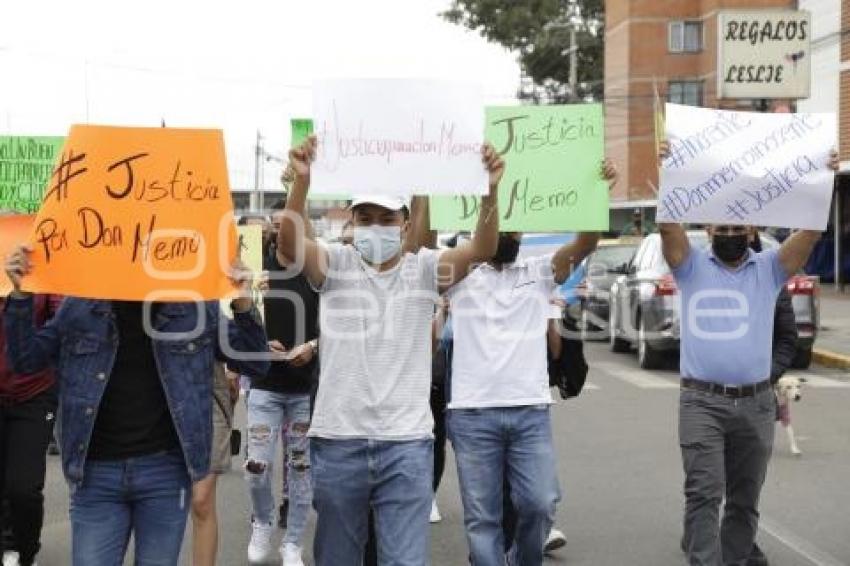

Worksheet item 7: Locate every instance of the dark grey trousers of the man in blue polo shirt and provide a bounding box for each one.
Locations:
[679,389,776,566]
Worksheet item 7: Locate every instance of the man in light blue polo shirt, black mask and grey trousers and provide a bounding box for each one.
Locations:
[659,149,838,566]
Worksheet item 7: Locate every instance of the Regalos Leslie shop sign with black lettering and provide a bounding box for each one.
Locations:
[717,10,812,99]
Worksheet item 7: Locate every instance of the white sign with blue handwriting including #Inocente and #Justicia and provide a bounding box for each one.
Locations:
[657,104,837,230]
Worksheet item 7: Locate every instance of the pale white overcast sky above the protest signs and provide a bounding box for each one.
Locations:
[0,0,519,189]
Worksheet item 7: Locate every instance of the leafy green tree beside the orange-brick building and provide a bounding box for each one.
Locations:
[441,0,605,102]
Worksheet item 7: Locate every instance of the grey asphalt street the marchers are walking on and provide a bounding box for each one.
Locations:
[33,343,850,566]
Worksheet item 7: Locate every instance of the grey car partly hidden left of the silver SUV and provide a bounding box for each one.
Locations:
[576,236,641,340]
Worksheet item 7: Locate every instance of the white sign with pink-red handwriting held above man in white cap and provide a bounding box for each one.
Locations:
[310,79,487,195]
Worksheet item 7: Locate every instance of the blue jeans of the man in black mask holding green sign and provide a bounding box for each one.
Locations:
[448,405,560,566]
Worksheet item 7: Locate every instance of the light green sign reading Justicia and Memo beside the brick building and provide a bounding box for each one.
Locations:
[431,104,608,232]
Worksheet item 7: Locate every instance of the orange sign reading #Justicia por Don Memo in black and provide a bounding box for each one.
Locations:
[24,126,236,301]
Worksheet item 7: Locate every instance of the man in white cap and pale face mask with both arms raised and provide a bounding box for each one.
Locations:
[278,137,504,566]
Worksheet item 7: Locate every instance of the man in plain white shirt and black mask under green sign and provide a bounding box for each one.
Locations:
[448,165,616,566]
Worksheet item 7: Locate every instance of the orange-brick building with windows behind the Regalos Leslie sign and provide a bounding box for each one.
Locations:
[605,0,796,229]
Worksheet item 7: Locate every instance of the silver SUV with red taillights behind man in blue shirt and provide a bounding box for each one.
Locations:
[609,230,820,369]
